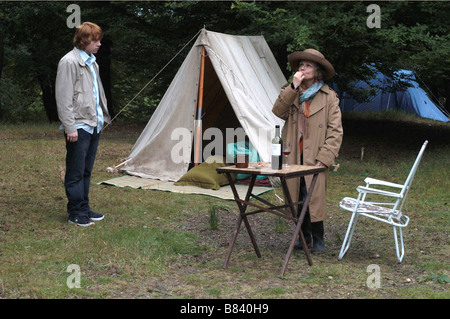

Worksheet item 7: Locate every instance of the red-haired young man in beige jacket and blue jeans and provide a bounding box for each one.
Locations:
[55,22,111,226]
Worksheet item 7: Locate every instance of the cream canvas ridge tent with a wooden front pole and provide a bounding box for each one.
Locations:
[123,29,287,181]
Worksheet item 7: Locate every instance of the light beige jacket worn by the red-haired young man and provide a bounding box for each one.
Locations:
[55,48,111,133]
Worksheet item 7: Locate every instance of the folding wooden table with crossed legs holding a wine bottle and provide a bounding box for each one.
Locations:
[217,163,325,276]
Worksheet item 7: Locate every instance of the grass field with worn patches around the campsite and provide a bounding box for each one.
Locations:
[0,117,450,299]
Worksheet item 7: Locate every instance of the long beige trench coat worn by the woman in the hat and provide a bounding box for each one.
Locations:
[272,84,343,223]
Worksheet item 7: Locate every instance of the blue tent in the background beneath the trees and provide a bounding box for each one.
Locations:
[337,70,449,122]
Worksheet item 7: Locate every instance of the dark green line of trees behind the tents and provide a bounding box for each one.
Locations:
[0,1,450,122]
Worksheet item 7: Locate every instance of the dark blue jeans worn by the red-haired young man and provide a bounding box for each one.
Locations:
[64,128,100,216]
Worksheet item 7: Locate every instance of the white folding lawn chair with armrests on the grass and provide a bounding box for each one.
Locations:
[338,141,428,263]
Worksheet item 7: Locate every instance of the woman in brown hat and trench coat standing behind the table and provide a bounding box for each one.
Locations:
[272,49,343,252]
